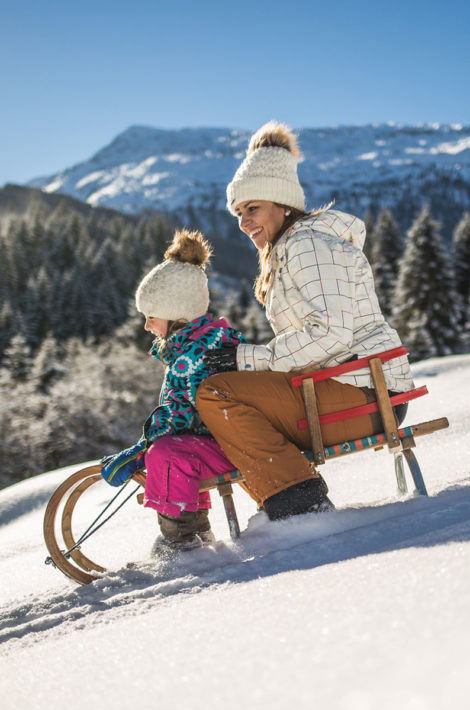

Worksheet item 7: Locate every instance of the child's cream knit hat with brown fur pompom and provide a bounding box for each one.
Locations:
[135,229,212,322]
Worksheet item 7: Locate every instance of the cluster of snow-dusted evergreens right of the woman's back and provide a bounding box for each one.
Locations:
[365,205,470,360]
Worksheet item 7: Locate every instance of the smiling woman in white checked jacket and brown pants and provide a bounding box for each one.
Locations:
[196,122,413,520]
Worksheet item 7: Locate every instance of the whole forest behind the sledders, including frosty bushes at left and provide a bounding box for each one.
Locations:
[0,186,470,486]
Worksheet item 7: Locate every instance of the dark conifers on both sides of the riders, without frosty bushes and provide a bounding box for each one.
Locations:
[0,195,470,369]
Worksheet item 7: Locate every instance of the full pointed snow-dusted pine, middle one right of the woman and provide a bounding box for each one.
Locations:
[393,205,460,360]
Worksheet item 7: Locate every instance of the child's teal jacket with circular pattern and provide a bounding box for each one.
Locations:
[144,313,246,443]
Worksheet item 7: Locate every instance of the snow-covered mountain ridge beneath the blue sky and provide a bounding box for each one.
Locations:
[30,124,470,241]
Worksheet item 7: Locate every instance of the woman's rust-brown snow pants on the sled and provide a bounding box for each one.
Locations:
[196,370,382,505]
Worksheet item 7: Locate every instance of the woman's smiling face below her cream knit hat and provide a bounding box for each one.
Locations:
[235,200,286,249]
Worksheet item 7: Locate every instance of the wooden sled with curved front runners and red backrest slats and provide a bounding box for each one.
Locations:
[44,347,449,584]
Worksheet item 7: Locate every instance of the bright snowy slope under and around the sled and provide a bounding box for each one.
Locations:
[0,355,470,710]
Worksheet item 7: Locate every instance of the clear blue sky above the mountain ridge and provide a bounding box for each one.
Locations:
[0,0,470,186]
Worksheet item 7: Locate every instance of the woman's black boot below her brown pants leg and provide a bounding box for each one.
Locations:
[263,476,334,520]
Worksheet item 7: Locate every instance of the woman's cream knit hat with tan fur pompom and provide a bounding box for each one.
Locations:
[227,121,305,216]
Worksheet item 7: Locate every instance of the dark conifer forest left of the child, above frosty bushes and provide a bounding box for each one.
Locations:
[0,195,173,360]
